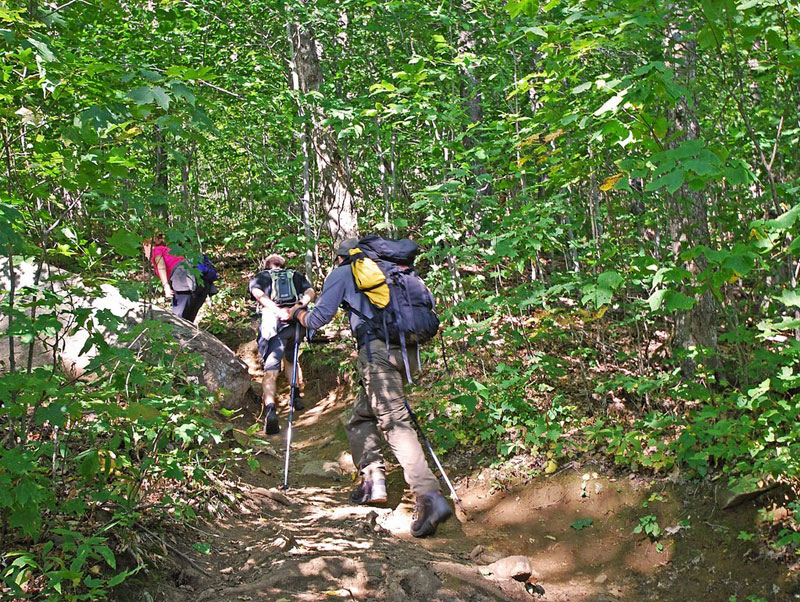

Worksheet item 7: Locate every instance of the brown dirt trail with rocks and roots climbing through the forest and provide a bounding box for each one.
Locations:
[136,336,800,602]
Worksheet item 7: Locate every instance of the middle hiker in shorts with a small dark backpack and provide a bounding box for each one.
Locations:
[250,254,315,435]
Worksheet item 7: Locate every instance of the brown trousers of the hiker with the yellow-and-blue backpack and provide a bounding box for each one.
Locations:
[345,339,440,495]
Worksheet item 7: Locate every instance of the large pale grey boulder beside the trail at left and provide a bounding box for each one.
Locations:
[0,257,250,408]
